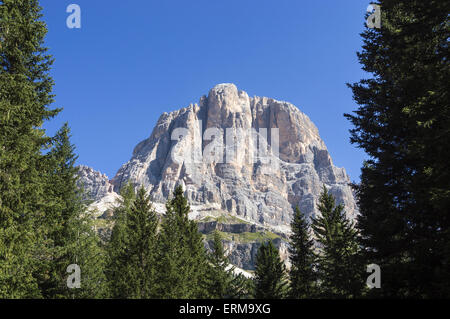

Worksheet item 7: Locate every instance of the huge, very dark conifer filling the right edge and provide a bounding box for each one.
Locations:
[346,0,450,298]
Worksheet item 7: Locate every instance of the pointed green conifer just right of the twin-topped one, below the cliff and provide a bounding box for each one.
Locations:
[157,186,209,299]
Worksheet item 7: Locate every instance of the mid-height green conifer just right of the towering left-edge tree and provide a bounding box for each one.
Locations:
[35,123,106,298]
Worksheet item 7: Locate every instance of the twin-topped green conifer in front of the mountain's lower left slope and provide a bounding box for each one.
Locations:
[107,184,162,299]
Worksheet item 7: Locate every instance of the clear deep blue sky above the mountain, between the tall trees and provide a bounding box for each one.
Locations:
[41,0,370,181]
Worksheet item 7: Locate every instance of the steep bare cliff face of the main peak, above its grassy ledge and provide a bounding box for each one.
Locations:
[107,83,357,227]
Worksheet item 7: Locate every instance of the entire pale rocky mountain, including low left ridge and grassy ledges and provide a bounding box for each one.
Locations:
[80,84,357,270]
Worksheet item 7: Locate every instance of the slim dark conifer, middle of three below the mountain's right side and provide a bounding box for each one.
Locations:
[289,207,316,299]
